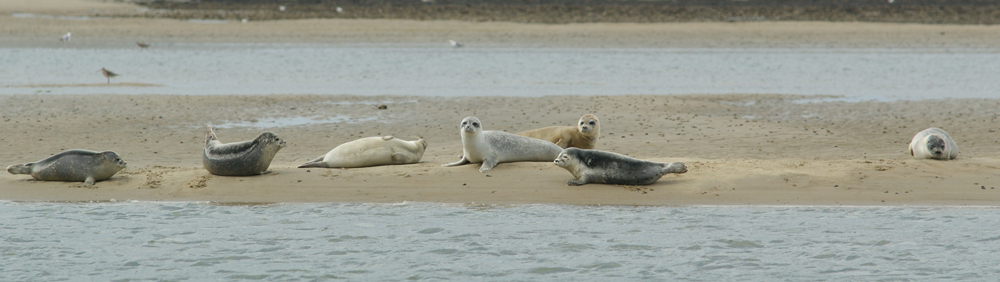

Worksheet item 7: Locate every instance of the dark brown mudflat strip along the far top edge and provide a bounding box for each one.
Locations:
[131,0,1000,24]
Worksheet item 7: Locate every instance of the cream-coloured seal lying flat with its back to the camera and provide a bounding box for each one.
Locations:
[299,136,427,168]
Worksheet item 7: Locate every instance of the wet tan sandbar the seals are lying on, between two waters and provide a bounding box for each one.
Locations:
[0,94,1000,206]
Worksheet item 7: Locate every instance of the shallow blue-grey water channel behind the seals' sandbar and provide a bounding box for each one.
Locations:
[0,42,1000,99]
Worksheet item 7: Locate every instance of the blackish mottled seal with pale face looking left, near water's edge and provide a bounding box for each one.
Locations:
[554,148,687,186]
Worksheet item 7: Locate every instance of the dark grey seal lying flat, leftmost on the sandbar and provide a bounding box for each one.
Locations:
[7,150,126,185]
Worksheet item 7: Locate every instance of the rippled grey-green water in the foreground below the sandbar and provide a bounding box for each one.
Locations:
[0,202,1000,281]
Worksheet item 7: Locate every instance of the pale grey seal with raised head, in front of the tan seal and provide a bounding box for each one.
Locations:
[444,117,562,172]
